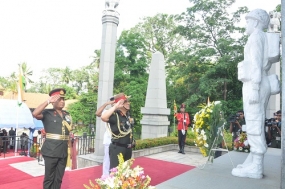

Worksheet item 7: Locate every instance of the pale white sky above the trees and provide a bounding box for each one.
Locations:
[0,0,281,82]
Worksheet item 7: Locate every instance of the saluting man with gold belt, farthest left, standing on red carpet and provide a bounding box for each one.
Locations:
[33,88,72,189]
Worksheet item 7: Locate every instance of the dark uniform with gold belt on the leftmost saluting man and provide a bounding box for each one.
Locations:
[41,109,71,189]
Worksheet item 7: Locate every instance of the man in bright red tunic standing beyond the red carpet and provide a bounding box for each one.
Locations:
[174,104,190,154]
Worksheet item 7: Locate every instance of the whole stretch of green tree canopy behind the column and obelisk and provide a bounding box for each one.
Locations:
[0,0,280,134]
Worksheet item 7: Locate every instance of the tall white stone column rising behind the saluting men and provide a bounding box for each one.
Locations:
[95,1,119,158]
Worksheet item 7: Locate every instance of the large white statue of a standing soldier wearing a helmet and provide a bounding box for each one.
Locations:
[232,9,275,179]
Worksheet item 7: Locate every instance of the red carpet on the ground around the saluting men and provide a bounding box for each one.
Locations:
[0,157,194,189]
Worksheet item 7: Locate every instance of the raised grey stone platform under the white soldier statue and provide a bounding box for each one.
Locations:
[156,148,281,189]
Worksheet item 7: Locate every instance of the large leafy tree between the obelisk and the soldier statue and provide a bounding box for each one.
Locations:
[172,0,248,109]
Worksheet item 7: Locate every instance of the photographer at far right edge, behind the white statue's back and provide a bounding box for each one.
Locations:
[268,110,281,148]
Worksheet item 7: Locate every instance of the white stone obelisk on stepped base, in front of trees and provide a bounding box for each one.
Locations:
[140,52,170,139]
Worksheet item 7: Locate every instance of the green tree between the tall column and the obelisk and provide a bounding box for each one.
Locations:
[114,30,150,135]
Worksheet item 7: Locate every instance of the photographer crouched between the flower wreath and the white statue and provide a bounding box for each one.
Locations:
[229,110,245,142]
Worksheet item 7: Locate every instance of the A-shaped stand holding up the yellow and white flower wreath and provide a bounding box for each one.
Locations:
[197,124,234,169]
